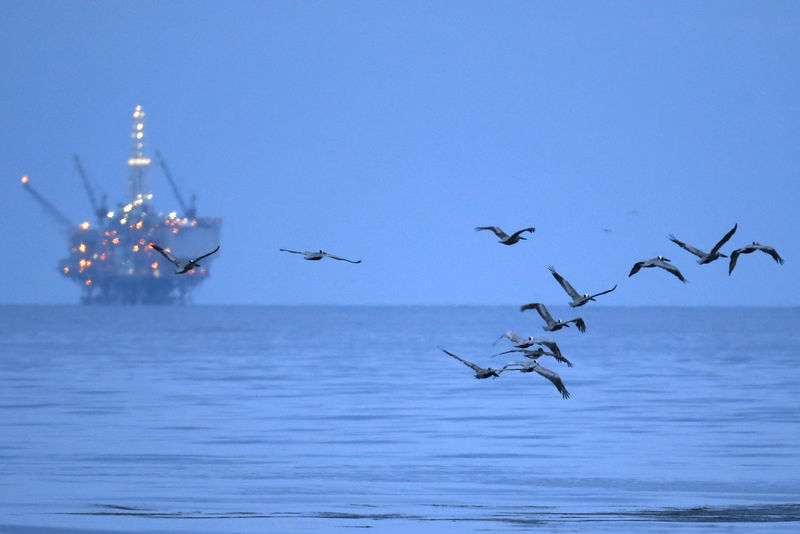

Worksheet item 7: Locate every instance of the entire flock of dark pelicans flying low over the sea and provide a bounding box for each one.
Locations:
[150,220,783,399]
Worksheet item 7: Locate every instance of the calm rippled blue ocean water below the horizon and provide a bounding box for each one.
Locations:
[0,304,800,533]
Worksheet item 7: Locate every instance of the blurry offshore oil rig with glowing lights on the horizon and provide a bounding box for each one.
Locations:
[22,106,222,304]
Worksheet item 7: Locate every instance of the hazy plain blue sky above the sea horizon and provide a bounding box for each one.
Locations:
[0,0,800,306]
